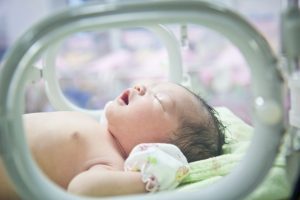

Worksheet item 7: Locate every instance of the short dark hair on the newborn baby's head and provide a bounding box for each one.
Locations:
[170,88,225,162]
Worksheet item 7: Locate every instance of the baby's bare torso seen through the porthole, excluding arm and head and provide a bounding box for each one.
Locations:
[24,112,124,188]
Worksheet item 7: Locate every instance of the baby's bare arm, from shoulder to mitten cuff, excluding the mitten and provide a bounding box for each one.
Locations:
[68,165,146,197]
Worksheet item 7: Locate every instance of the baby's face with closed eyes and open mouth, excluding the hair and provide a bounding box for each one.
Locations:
[106,83,197,155]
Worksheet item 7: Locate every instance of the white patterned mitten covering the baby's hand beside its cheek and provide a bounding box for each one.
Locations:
[125,143,189,192]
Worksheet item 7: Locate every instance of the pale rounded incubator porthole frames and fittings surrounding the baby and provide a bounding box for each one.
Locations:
[0,0,300,200]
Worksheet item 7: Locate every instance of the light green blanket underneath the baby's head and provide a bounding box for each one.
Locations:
[177,108,290,200]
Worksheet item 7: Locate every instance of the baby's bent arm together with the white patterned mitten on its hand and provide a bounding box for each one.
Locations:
[68,143,189,196]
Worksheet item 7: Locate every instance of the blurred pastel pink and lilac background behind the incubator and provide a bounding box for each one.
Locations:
[0,0,281,123]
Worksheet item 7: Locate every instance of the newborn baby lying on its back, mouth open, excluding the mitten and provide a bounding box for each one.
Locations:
[0,82,224,199]
